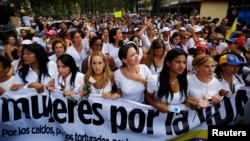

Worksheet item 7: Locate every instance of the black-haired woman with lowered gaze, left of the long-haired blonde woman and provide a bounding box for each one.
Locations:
[46,54,84,97]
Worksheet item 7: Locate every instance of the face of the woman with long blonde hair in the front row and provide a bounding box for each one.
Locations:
[91,56,105,74]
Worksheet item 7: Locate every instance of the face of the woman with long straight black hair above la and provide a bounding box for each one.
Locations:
[167,55,187,75]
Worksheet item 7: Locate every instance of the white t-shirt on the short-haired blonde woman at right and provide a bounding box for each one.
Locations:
[187,74,222,102]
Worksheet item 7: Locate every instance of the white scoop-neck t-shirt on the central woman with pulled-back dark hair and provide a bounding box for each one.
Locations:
[114,64,151,103]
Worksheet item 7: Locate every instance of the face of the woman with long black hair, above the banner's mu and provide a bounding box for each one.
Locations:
[23,49,37,65]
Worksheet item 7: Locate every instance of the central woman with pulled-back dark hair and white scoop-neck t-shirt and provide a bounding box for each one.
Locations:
[115,43,151,103]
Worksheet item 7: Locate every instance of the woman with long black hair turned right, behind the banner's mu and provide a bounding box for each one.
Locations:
[11,44,57,93]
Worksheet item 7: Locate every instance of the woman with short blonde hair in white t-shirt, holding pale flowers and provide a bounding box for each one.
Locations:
[186,54,222,108]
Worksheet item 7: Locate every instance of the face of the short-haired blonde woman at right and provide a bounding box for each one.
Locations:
[195,62,216,79]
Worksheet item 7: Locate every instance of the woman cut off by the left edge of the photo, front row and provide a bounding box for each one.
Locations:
[0,55,14,95]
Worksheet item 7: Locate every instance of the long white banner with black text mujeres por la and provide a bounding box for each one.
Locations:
[0,87,250,141]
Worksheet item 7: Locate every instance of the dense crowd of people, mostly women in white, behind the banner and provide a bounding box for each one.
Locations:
[0,0,250,112]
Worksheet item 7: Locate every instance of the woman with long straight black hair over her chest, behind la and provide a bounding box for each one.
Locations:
[146,48,188,113]
